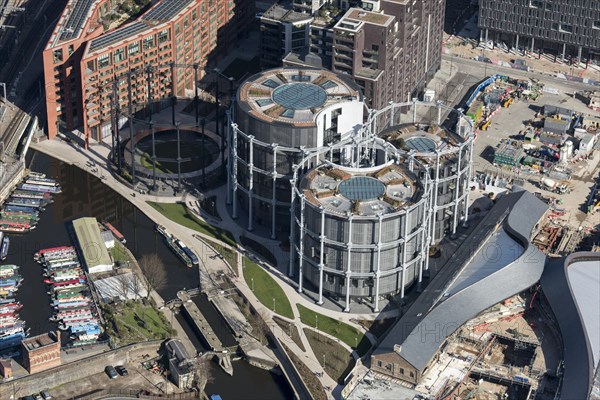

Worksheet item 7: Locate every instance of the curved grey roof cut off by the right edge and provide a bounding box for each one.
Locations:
[541,252,600,399]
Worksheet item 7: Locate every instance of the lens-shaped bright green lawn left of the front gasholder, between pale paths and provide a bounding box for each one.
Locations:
[244,257,294,319]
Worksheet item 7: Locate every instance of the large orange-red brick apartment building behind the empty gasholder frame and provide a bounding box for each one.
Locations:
[43,0,254,144]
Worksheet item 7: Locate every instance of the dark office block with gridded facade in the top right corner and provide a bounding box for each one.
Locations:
[479,0,600,60]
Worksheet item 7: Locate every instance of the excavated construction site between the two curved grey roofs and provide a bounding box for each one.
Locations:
[416,292,560,400]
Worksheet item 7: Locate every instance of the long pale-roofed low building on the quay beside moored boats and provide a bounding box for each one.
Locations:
[73,217,112,271]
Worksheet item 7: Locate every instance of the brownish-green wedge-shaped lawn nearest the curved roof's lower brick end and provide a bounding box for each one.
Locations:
[304,328,355,383]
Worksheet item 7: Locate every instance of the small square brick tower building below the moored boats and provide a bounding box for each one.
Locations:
[21,332,61,374]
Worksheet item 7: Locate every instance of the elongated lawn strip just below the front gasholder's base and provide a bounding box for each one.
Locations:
[296,304,371,357]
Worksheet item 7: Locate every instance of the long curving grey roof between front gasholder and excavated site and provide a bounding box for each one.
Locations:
[374,191,548,371]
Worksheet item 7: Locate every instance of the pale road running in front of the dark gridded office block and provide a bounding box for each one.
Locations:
[442,54,598,91]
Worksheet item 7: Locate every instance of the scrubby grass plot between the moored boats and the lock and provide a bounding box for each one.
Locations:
[102,300,174,346]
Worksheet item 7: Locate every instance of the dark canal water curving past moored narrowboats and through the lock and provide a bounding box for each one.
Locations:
[5,152,292,400]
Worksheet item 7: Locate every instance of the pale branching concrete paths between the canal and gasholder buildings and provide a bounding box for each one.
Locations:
[32,131,384,395]
